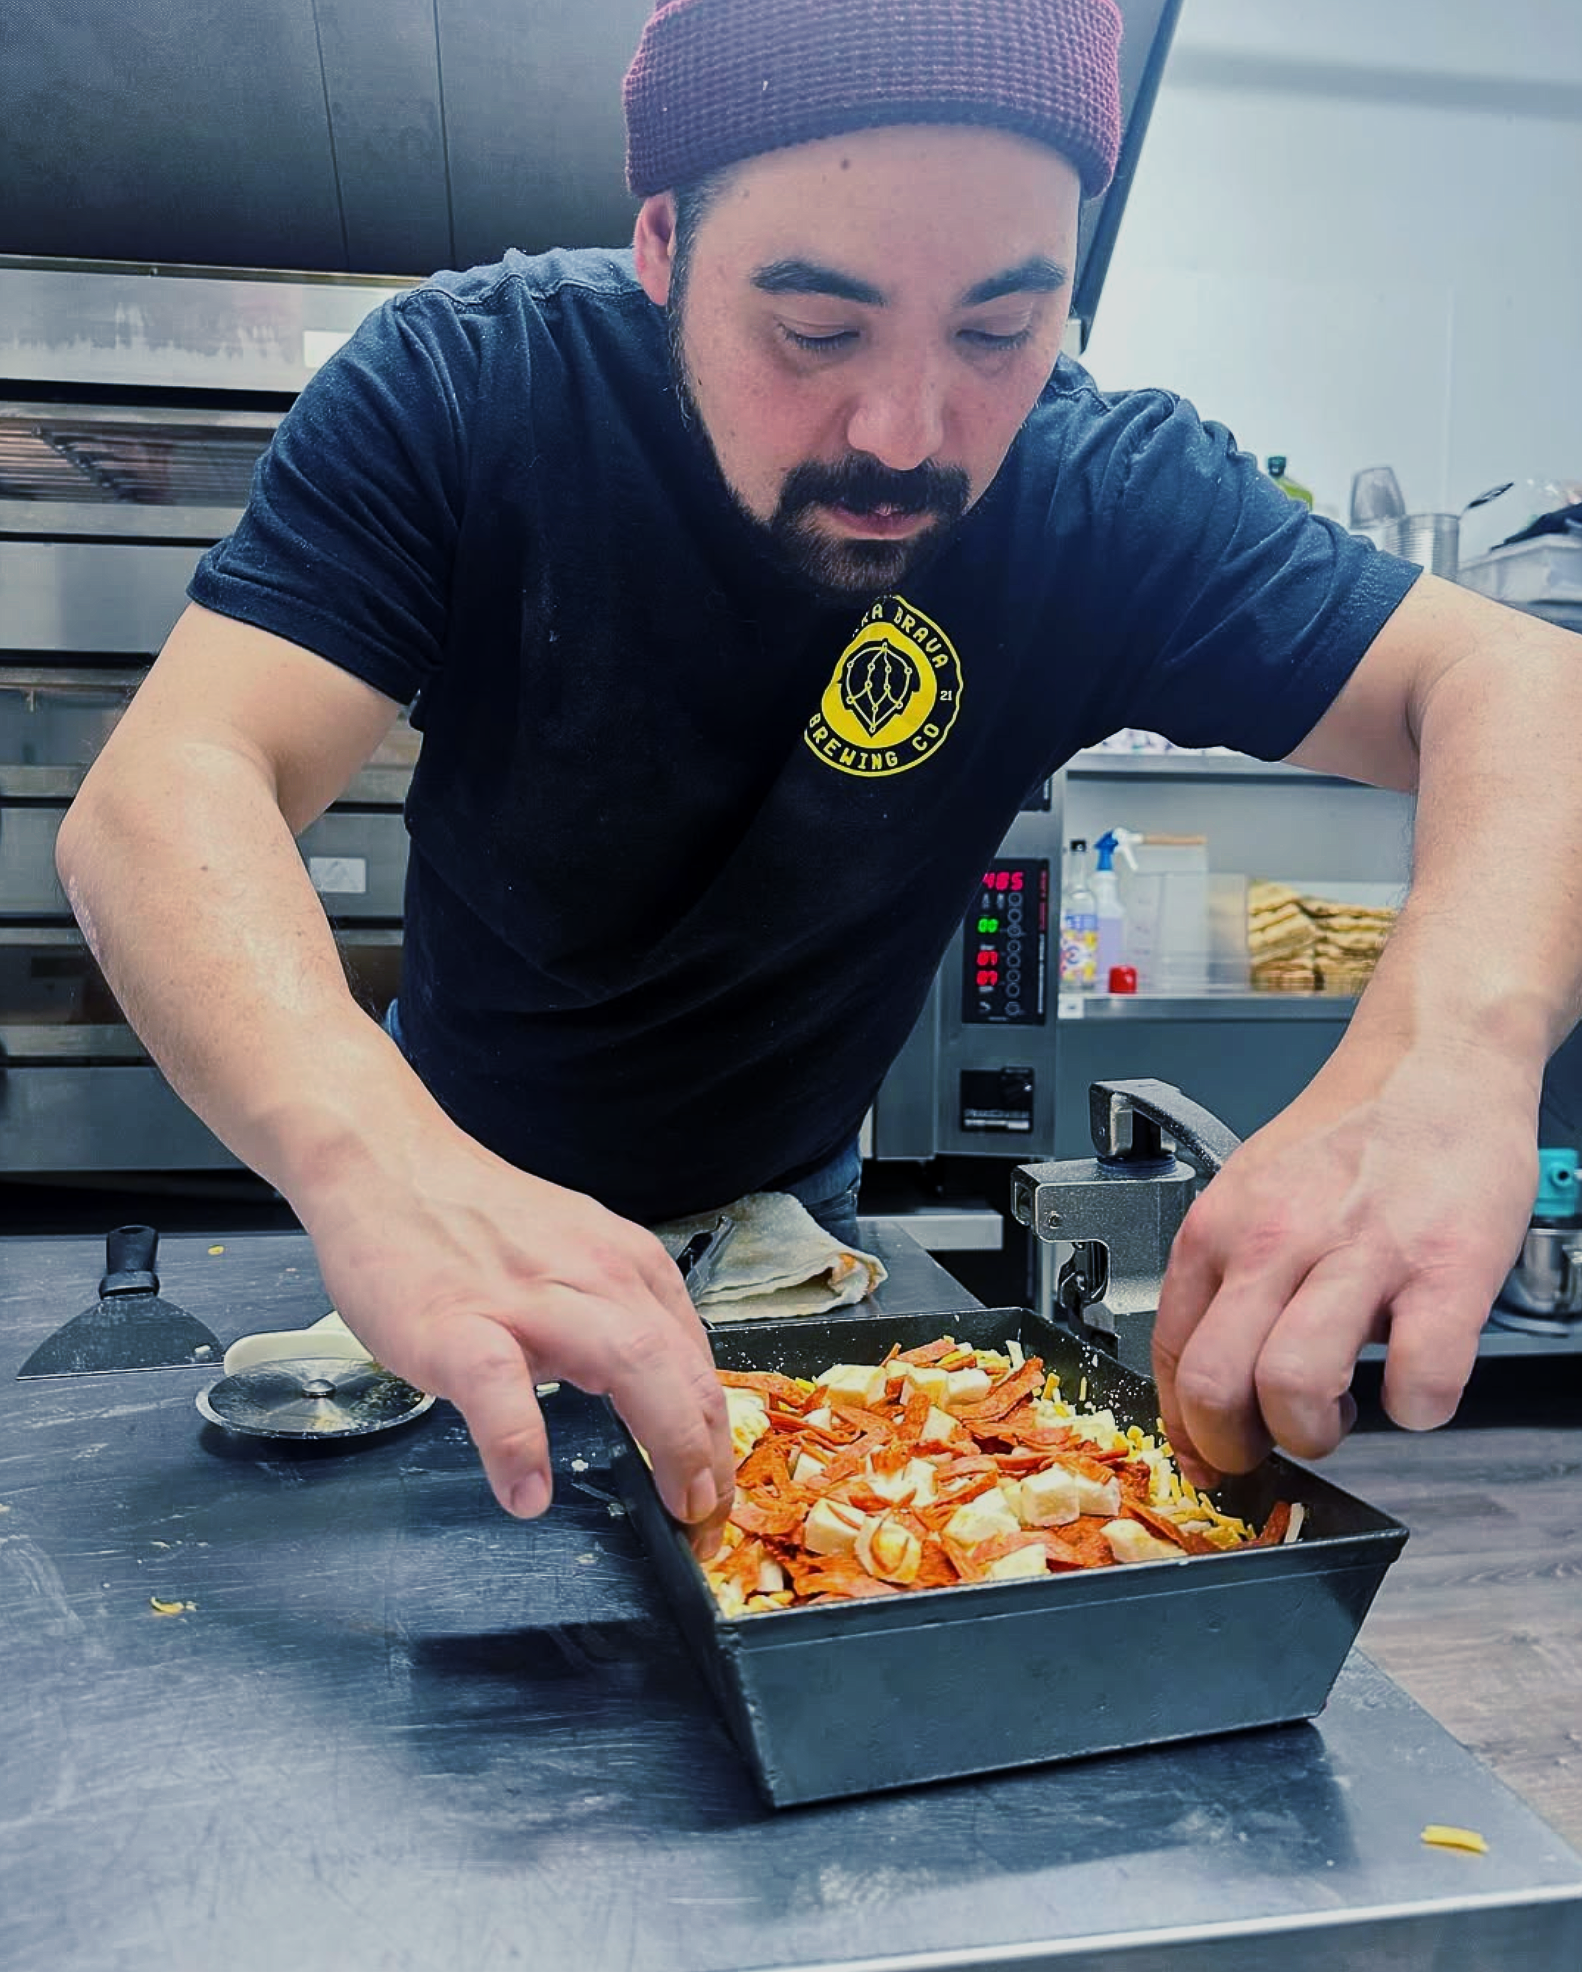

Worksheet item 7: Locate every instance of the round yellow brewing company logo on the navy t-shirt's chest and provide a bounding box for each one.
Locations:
[803,596,961,775]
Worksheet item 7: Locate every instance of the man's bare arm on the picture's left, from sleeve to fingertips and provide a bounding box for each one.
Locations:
[57,607,734,1542]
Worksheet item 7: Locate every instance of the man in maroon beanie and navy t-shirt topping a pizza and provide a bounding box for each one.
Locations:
[59,0,1582,1546]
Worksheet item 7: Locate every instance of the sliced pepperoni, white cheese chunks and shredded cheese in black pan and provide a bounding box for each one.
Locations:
[704,1335,1302,1615]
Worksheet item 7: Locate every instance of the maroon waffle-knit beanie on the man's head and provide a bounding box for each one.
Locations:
[623,0,1120,199]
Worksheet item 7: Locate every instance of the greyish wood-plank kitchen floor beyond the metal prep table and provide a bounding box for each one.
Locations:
[0,1173,1582,1850]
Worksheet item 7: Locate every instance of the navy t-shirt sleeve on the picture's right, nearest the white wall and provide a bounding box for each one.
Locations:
[1049,390,1418,759]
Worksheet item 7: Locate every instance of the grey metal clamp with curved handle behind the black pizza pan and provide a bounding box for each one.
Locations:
[1010,1081,1241,1373]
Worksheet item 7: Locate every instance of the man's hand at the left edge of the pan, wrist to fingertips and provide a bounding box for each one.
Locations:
[300,1124,734,1554]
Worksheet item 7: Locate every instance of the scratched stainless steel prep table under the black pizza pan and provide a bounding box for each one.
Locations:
[0,1221,1582,1972]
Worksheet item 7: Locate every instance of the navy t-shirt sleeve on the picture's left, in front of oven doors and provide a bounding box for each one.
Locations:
[187,290,477,704]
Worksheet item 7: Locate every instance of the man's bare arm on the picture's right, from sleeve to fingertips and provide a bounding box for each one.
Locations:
[1154,576,1582,1483]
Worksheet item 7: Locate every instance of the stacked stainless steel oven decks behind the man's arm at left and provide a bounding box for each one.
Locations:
[0,270,416,1175]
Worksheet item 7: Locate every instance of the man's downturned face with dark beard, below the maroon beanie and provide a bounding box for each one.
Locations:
[635,124,1081,598]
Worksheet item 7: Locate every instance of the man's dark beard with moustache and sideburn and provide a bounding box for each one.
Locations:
[667,299,972,603]
